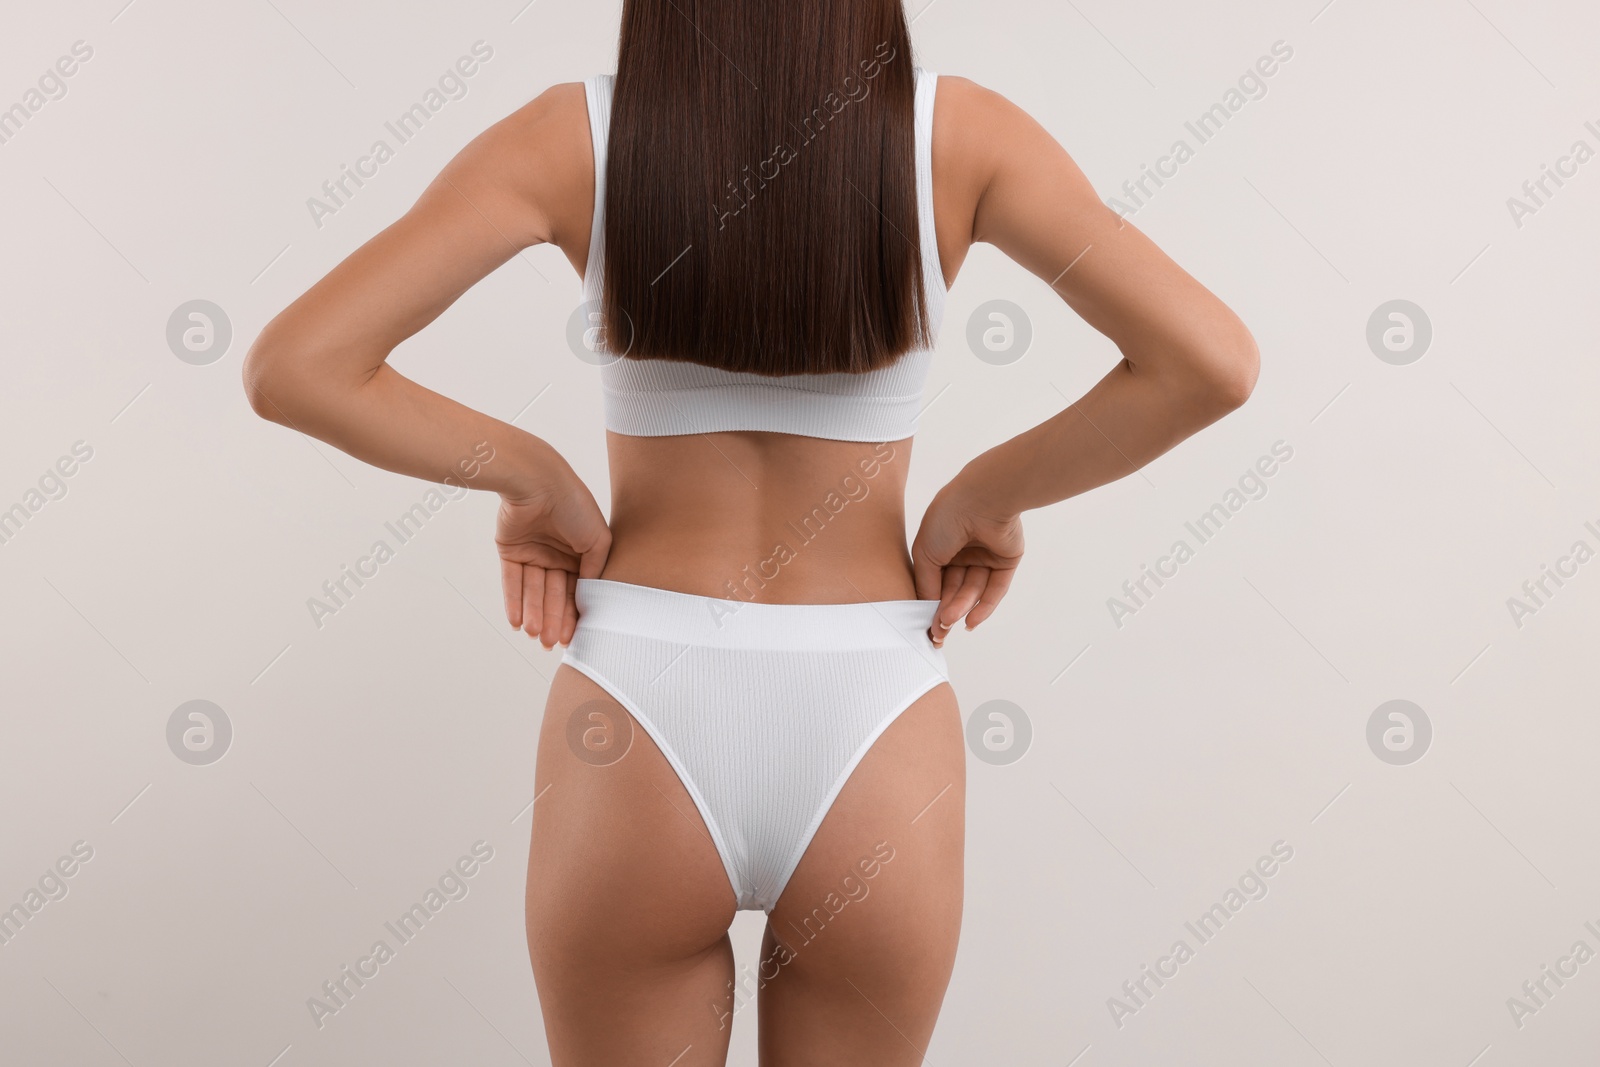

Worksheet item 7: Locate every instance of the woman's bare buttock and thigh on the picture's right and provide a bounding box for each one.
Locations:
[757,685,966,1067]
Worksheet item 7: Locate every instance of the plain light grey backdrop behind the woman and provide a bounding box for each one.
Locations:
[0,0,1600,1067]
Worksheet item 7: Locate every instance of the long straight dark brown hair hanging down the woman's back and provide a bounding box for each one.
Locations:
[600,0,930,374]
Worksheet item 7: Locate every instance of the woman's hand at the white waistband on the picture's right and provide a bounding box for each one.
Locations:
[910,475,1022,646]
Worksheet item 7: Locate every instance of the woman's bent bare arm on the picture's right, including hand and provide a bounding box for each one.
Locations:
[912,78,1259,641]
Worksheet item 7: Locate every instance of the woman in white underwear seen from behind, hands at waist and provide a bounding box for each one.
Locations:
[245,0,1256,1067]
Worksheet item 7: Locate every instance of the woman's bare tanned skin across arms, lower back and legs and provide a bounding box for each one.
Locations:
[245,77,1258,1067]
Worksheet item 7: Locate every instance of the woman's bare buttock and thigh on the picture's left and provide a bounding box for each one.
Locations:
[528,664,734,1067]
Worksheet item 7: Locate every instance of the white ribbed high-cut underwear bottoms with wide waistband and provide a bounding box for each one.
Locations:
[562,577,949,912]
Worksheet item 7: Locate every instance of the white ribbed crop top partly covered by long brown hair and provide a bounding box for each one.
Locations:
[582,67,947,442]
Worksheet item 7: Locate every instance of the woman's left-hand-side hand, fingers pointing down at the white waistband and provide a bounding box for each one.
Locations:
[494,466,611,651]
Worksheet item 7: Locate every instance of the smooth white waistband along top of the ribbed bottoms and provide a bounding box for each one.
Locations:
[574,577,944,664]
